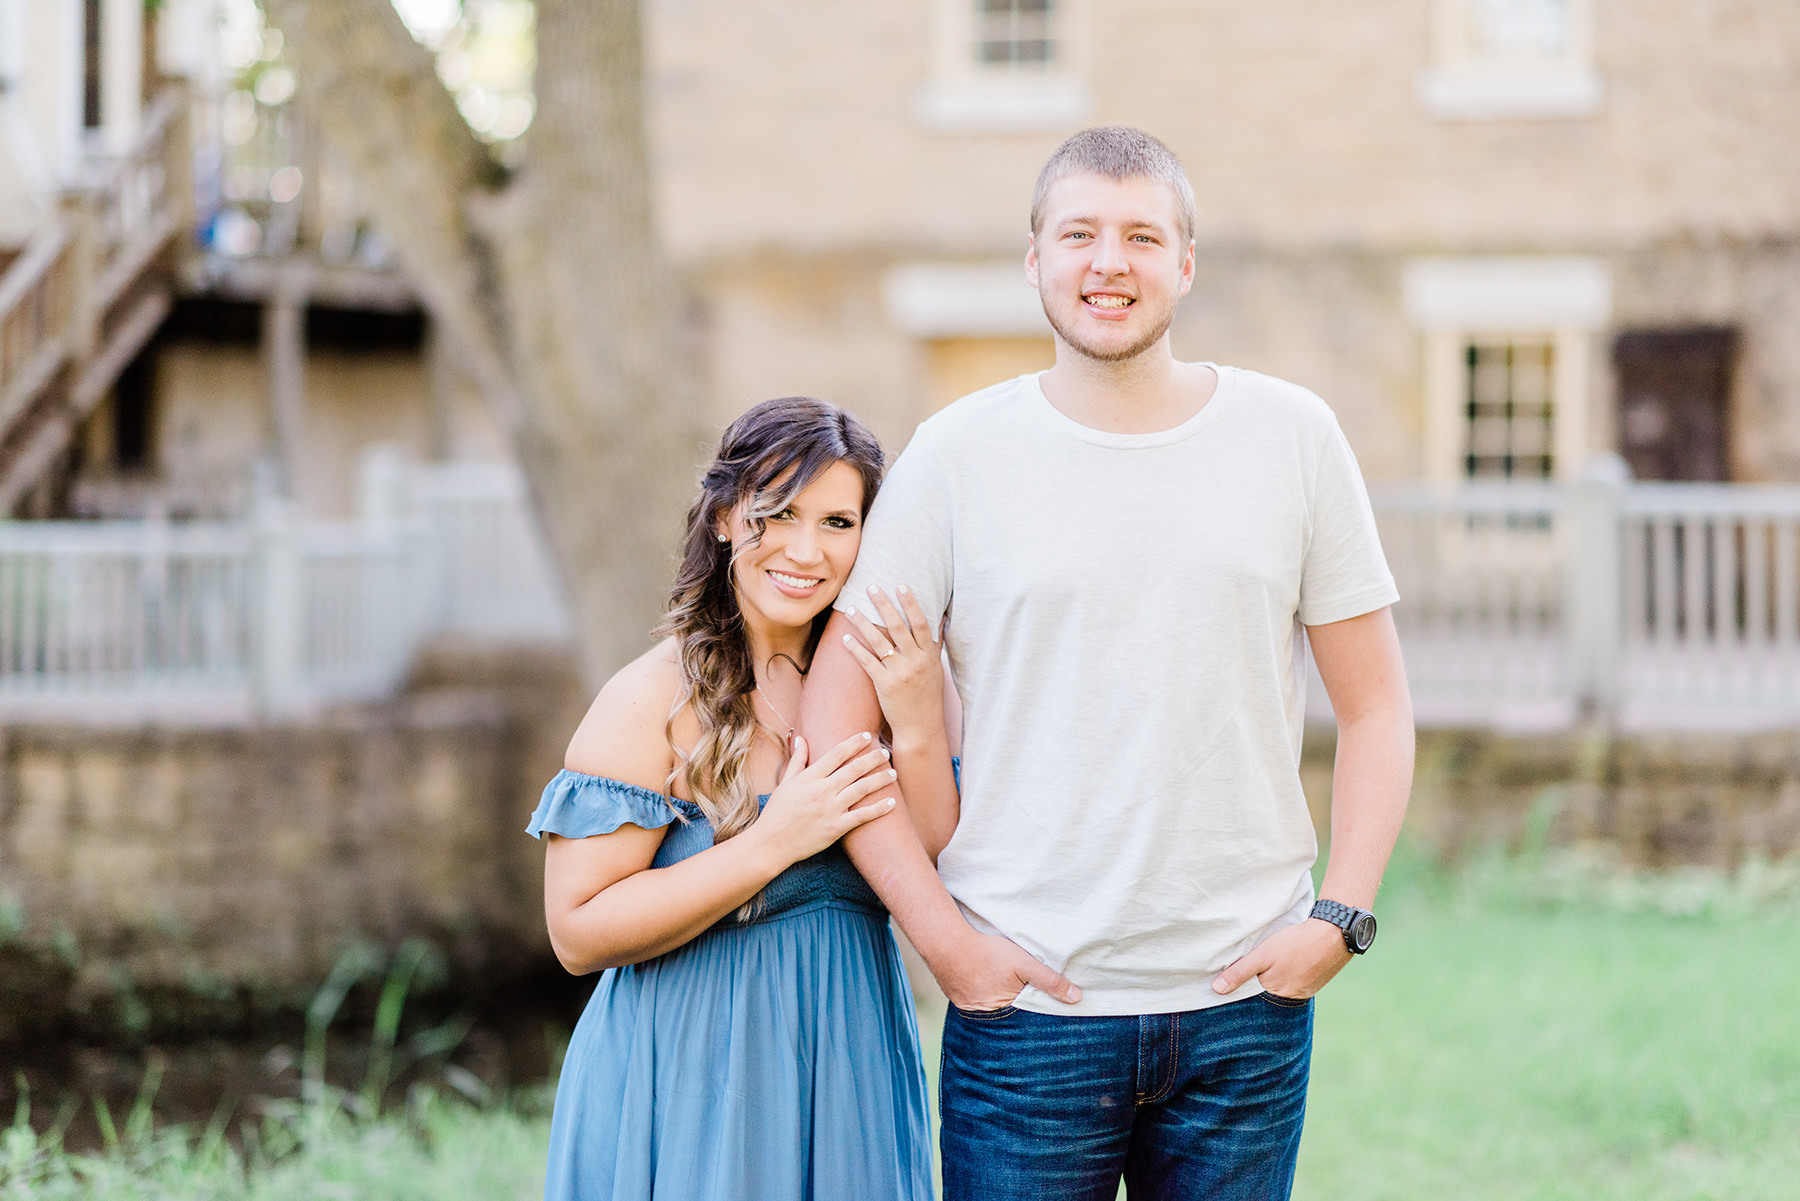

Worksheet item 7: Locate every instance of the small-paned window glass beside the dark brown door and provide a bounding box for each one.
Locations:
[1463,339,1557,479]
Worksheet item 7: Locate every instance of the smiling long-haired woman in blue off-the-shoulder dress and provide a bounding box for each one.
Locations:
[529,398,954,1201]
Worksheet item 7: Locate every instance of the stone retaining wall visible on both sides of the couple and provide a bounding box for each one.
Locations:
[0,680,1800,1041]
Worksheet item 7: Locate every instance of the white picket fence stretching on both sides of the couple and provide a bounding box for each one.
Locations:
[14,452,1800,729]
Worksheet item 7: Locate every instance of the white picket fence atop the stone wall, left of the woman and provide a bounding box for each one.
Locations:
[0,452,571,722]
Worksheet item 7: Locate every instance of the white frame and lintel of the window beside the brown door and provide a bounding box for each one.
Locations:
[1402,256,1613,484]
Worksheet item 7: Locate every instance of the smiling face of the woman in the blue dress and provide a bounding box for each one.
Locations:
[729,461,862,634]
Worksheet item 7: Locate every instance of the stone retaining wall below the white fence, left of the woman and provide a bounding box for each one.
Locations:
[0,652,581,1039]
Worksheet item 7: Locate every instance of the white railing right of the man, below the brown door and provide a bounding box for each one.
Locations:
[1346,459,1800,729]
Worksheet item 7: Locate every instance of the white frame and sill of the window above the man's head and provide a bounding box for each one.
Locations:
[913,0,1094,133]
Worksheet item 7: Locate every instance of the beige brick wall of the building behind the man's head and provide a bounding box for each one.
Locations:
[650,0,1800,481]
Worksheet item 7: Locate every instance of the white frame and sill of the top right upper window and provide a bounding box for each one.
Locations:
[1415,0,1606,121]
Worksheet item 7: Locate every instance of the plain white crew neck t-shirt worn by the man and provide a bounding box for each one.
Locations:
[839,364,1399,1014]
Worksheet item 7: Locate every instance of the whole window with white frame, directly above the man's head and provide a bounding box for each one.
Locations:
[913,0,1093,133]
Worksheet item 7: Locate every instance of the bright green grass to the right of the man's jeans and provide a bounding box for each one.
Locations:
[1296,857,1800,1201]
